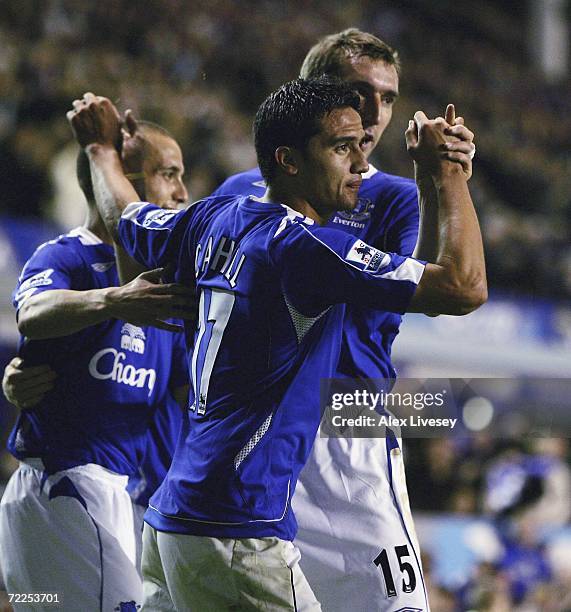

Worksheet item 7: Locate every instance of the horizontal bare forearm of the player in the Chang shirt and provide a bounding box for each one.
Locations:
[18,287,122,340]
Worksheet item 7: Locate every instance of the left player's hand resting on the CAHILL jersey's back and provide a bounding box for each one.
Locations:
[107,268,197,332]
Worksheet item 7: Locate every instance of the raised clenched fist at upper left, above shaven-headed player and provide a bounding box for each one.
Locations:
[67,92,121,149]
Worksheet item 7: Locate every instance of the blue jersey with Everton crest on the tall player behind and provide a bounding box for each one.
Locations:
[213,165,419,378]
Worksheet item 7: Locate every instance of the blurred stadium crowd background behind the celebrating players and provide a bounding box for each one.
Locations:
[0,0,571,612]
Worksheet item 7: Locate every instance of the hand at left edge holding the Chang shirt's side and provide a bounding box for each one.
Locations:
[2,357,57,410]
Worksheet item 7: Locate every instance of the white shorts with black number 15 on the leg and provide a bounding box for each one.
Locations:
[293,433,429,612]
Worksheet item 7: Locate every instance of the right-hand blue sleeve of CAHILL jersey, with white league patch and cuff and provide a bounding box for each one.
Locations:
[270,221,425,316]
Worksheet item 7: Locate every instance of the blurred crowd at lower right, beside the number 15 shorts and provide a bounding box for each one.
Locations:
[407,435,571,612]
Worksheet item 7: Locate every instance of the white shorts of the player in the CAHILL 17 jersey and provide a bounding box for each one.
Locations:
[143,525,321,612]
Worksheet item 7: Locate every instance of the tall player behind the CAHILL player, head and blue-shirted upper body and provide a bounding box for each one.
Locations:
[212,28,474,378]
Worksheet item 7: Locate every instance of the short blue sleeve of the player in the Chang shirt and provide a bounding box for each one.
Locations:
[13,241,83,311]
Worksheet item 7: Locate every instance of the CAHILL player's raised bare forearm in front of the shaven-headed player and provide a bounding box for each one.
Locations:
[86,144,139,242]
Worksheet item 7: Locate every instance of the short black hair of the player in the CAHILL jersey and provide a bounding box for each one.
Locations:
[254,76,359,183]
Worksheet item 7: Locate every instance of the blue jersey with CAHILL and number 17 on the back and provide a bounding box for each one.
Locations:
[119,196,424,539]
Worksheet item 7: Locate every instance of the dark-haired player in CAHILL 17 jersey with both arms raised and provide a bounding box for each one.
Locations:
[68,79,486,610]
